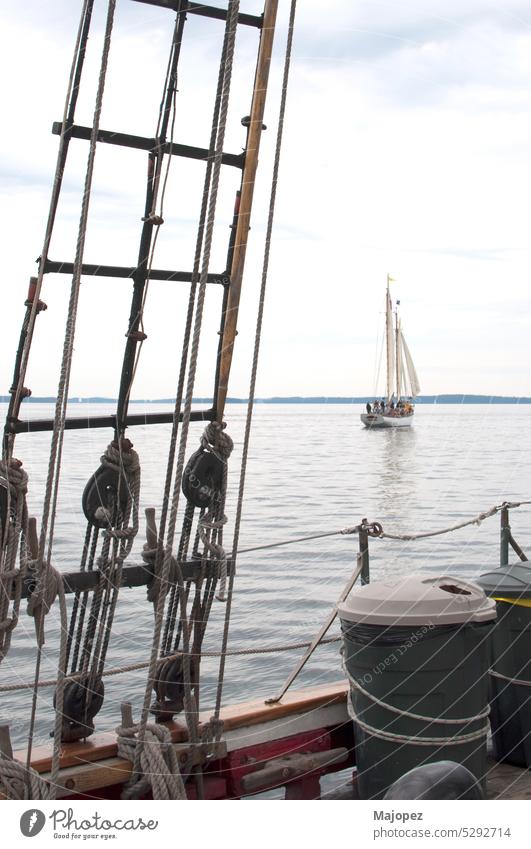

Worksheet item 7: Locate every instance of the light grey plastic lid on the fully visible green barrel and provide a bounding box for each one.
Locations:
[338,573,496,626]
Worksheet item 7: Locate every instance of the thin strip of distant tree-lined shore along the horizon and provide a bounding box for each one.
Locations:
[4,395,531,404]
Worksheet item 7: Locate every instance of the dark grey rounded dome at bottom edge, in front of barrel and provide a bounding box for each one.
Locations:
[384,761,484,800]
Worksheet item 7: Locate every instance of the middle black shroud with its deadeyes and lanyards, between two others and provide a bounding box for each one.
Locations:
[60,1,184,739]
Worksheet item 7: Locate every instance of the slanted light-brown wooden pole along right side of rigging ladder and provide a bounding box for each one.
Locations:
[215,0,278,421]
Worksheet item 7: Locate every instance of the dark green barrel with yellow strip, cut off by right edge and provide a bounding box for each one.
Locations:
[478,563,531,767]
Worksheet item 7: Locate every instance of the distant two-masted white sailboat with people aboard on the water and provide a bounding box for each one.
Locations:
[360,274,420,428]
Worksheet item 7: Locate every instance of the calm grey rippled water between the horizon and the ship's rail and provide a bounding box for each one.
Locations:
[0,404,531,745]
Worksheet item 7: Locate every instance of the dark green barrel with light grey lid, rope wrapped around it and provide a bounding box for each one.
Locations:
[338,574,496,799]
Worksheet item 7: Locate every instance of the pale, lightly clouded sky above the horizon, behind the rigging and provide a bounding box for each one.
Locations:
[0,0,531,398]
